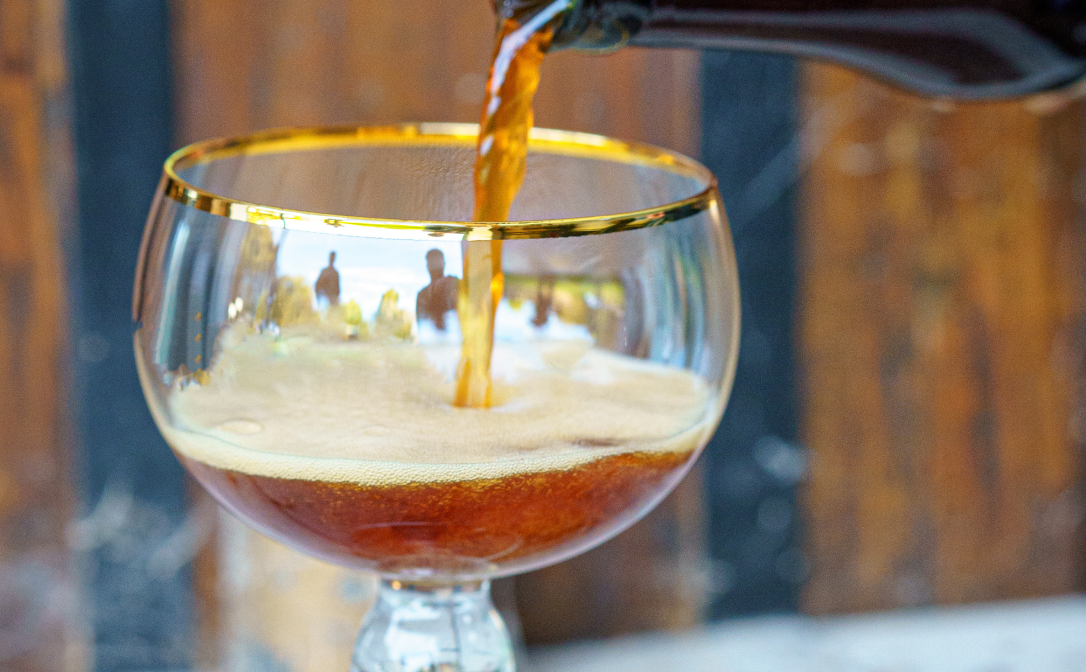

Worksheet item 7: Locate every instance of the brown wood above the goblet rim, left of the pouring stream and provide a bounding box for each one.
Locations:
[174,0,494,142]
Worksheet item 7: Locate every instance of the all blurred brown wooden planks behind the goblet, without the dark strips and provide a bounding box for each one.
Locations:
[0,0,1086,672]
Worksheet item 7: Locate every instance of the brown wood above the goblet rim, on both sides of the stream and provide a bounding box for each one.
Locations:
[173,0,698,153]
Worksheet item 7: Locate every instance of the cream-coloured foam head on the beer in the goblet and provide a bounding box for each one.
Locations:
[162,329,718,485]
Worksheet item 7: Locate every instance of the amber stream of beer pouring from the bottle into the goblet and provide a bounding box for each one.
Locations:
[453,0,569,408]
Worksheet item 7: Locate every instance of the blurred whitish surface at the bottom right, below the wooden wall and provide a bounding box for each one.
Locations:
[522,596,1086,672]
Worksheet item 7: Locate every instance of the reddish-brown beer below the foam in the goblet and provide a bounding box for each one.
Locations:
[181,452,692,575]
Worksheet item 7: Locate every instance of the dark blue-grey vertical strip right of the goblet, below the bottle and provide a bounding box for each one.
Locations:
[702,51,804,618]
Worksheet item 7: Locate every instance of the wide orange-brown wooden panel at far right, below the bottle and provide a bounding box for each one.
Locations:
[798,66,1086,612]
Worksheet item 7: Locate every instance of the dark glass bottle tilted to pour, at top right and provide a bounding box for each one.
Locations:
[543,0,1086,99]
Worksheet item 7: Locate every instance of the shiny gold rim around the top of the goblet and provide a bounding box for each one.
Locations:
[161,123,717,240]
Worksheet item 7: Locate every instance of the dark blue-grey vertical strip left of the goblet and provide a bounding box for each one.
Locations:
[66,0,198,670]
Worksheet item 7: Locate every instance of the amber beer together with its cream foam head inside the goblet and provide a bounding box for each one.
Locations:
[162,325,717,578]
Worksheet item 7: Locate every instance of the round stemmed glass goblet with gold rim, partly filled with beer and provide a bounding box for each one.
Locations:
[134,124,738,672]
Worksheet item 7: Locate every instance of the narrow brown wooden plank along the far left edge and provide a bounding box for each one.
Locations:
[0,0,81,672]
